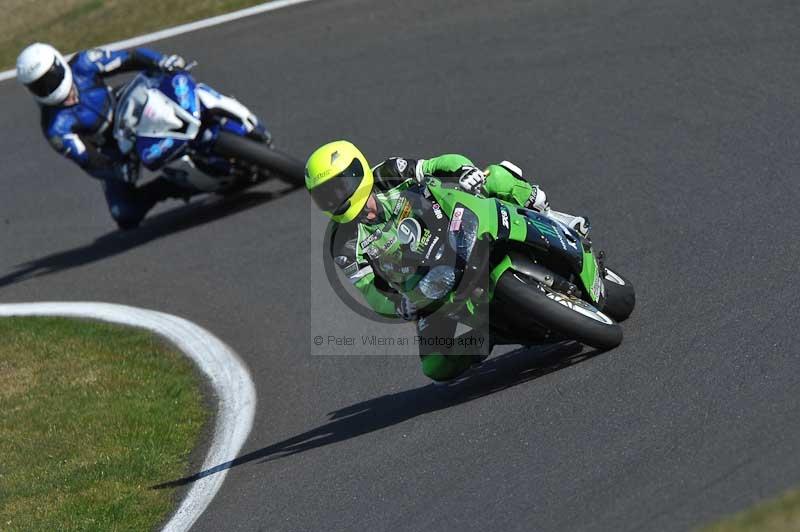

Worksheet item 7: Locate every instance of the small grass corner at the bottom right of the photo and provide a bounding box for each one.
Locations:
[702,490,800,532]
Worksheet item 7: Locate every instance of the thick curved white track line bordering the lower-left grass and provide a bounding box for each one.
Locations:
[0,303,256,532]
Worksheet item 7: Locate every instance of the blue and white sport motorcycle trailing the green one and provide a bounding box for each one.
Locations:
[114,69,304,194]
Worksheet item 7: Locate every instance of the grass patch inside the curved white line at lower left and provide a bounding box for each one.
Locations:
[0,318,208,531]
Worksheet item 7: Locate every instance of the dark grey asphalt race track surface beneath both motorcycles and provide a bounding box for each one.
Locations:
[0,0,800,531]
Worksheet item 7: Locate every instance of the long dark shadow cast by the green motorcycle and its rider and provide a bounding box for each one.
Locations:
[151,342,600,489]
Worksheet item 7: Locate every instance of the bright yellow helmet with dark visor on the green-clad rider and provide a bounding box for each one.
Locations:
[306,140,374,223]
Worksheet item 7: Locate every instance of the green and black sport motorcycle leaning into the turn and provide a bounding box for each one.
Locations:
[390,178,636,350]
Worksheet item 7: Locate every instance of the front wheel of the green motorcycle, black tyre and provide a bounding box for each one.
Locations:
[495,270,622,350]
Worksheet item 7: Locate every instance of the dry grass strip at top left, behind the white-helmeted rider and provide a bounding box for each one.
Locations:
[0,0,264,70]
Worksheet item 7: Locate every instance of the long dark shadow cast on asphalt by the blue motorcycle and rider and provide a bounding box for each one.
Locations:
[0,188,295,287]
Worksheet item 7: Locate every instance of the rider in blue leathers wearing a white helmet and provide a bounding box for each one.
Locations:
[17,43,188,229]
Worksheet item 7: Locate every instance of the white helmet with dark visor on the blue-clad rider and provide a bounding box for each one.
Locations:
[17,42,72,105]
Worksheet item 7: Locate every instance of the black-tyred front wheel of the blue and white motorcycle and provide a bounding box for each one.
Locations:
[214,131,305,187]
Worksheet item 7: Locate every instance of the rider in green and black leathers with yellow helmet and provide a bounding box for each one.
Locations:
[305,140,588,382]
